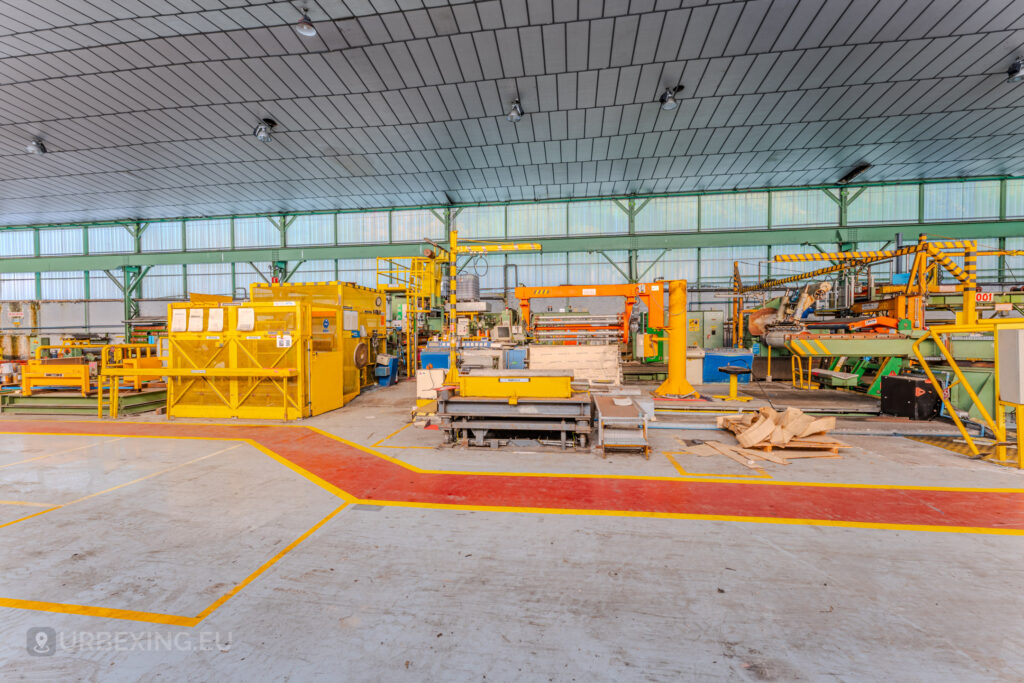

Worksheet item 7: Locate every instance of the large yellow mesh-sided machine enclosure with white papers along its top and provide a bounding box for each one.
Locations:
[164,282,385,420]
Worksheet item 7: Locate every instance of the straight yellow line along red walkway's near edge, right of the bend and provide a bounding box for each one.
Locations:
[359,499,1024,536]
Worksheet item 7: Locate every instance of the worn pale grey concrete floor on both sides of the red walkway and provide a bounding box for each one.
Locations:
[0,384,1024,681]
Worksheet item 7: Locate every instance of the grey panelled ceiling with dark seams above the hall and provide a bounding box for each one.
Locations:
[0,0,1024,225]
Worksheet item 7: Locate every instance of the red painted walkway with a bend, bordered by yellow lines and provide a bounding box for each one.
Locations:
[8,420,1024,531]
